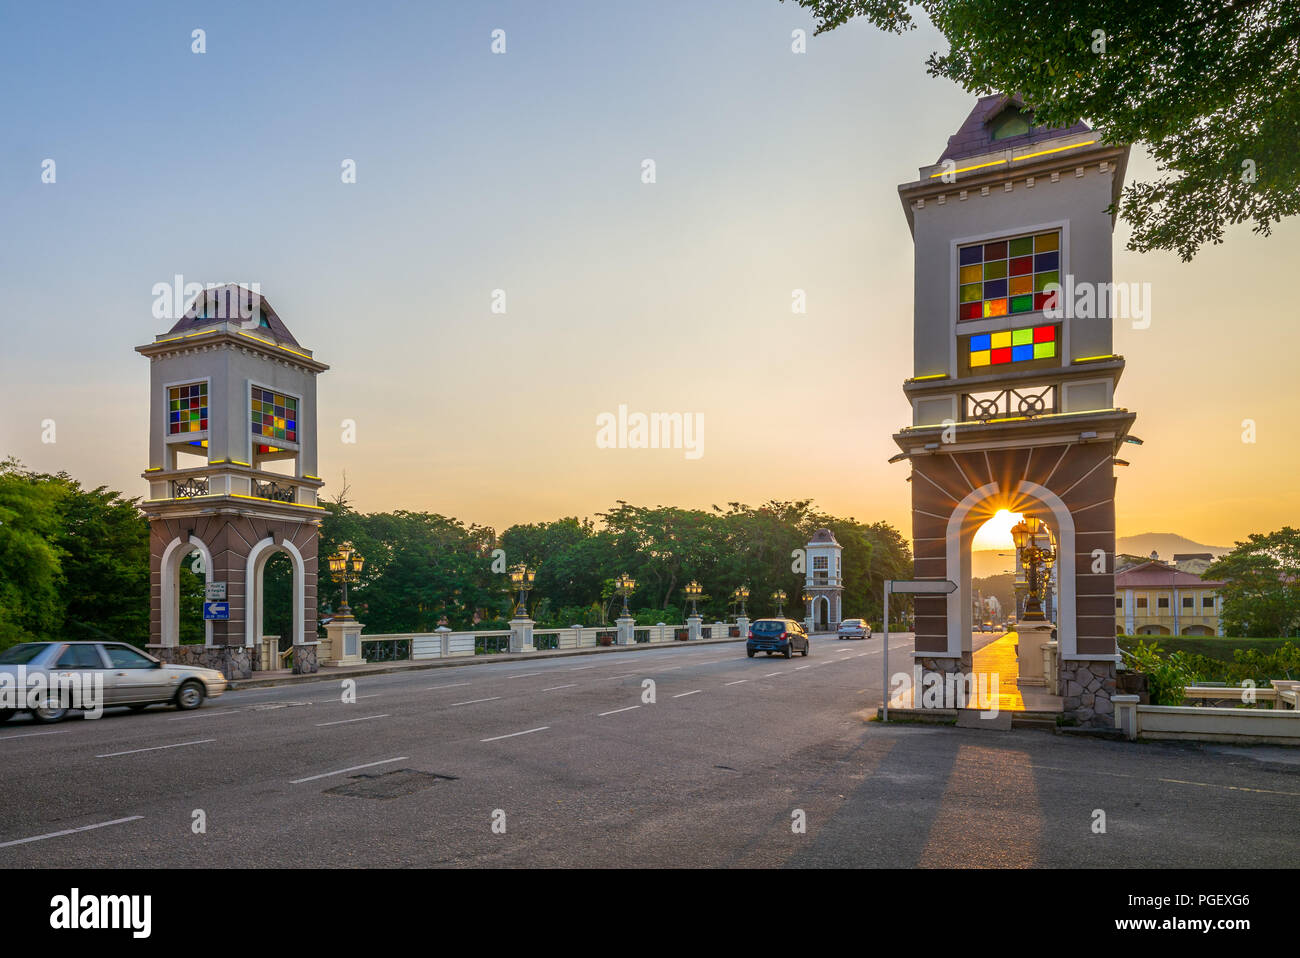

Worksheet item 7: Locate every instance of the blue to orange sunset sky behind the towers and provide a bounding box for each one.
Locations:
[0,0,1300,545]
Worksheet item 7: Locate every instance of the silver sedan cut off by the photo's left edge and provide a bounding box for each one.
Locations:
[0,642,228,721]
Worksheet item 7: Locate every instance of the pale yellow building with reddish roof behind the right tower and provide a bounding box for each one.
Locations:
[1115,559,1223,636]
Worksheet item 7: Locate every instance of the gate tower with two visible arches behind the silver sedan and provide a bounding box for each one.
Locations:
[137,286,329,679]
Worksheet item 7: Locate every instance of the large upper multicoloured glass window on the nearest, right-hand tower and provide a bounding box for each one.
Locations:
[957,230,1061,320]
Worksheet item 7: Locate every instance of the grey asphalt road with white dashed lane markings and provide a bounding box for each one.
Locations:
[0,636,1300,868]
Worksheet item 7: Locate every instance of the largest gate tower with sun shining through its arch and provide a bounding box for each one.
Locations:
[894,96,1135,724]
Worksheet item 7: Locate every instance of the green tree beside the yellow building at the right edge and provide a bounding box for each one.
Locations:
[1204,526,1300,638]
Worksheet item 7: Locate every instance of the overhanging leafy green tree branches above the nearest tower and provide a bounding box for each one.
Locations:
[783,0,1300,260]
